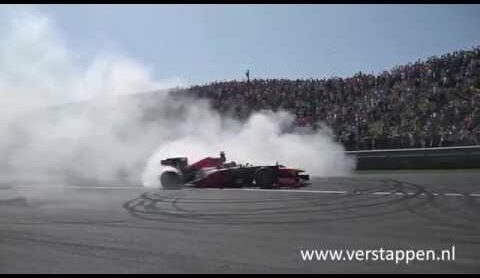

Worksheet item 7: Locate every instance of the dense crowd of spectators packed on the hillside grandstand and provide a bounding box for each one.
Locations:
[174,47,480,150]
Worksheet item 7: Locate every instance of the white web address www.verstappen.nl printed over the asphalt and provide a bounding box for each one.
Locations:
[300,245,455,264]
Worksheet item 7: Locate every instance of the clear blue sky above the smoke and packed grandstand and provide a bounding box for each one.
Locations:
[37,4,480,84]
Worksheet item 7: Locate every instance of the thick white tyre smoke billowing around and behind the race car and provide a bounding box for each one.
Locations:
[0,9,355,187]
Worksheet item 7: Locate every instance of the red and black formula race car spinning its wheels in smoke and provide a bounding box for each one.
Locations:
[160,152,310,189]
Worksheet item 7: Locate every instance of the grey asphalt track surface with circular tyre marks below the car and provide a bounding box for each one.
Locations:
[0,170,480,273]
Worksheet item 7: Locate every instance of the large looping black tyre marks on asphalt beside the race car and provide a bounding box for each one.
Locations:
[123,180,440,225]
